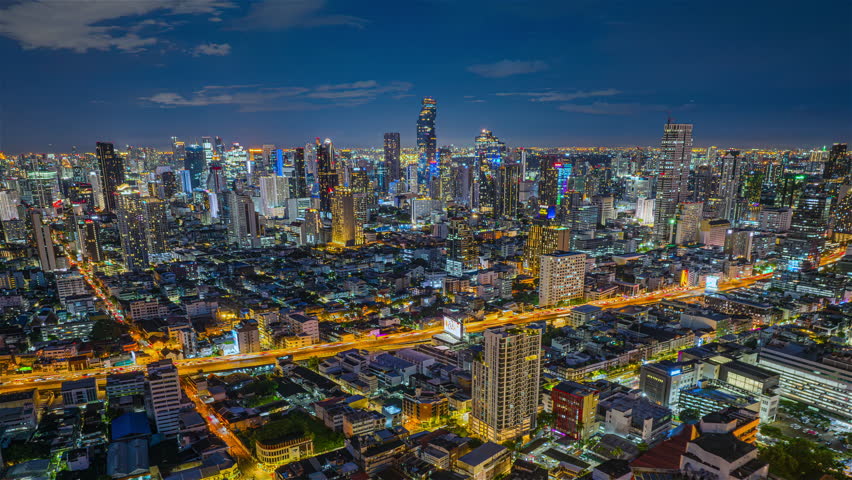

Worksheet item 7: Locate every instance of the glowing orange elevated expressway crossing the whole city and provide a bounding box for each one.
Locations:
[5,246,843,393]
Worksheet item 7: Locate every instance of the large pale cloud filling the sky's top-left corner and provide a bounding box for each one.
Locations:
[0,0,234,53]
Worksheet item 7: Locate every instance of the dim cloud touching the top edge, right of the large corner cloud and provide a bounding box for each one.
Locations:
[234,0,367,31]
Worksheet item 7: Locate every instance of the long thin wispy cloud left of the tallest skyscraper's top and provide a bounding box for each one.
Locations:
[140,80,412,112]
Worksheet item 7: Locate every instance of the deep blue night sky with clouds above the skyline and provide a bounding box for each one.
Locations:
[0,0,852,153]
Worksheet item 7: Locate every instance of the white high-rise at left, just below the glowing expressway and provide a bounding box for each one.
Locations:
[145,359,181,436]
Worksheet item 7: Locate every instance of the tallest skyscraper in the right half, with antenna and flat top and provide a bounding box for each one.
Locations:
[654,122,692,243]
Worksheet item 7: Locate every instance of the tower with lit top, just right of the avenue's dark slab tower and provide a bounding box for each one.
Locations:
[115,184,149,272]
